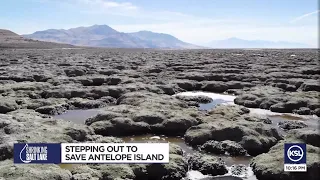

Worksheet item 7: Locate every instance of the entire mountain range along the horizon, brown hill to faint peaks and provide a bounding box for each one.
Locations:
[0,25,314,49]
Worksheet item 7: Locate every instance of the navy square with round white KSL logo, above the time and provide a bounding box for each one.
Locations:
[284,143,307,164]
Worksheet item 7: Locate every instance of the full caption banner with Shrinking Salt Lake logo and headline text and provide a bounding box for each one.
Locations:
[14,143,169,164]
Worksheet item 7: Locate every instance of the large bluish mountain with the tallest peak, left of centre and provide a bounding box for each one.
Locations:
[23,25,199,49]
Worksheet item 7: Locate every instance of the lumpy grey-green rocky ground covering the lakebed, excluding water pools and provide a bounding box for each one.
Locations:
[0,49,320,180]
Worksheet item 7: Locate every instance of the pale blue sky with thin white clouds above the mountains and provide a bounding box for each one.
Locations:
[0,0,320,46]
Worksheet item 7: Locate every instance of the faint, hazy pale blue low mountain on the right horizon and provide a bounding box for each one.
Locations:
[207,37,311,48]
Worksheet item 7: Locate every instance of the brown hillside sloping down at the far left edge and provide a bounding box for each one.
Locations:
[0,29,74,49]
